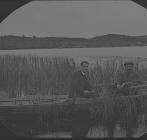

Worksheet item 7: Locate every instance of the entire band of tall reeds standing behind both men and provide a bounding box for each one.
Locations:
[0,55,147,97]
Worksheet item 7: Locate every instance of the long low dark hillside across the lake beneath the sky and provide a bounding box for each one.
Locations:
[0,34,147,50]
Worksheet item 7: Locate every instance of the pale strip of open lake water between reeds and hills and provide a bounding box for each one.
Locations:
[0,46,147,58]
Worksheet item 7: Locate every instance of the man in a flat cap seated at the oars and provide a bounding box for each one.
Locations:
[117,61,143,96]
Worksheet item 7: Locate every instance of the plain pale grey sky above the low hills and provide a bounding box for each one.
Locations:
[0,1,147,38]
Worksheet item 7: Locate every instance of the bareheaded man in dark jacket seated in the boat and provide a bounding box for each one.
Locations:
[70,61,95,98]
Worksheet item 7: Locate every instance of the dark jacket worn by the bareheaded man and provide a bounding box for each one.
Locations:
[70,71,91,97]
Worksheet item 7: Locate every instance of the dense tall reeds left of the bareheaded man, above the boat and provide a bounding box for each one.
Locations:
[0,56,75,97]
